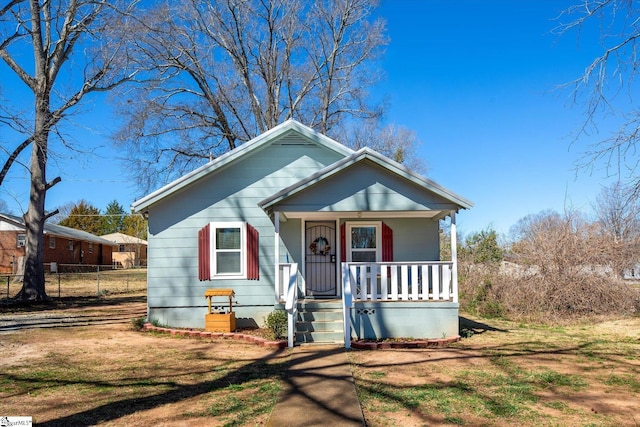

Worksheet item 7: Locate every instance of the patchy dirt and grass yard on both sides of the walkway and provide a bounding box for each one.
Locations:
[0,296,640,427]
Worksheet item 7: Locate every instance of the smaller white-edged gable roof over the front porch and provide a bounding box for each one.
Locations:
[259,147,473,216]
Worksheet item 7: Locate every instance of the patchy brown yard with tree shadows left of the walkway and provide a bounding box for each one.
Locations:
[0,296,289,426]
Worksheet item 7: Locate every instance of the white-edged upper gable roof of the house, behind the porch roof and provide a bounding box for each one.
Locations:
[131,119,353,212]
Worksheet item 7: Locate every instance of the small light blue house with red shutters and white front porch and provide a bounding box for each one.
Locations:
[133,120,472,347]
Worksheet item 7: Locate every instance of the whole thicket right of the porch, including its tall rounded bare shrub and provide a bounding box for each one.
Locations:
[458,211,640,324]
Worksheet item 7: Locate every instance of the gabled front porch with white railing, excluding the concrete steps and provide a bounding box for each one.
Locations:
[259,148,472,348]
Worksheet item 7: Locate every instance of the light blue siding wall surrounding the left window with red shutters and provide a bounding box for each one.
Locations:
[148,141,341,327]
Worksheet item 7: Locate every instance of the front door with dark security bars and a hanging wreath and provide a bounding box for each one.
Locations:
[305,221,338,297]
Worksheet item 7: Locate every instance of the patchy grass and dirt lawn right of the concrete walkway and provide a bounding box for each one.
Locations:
[352,314,640,427]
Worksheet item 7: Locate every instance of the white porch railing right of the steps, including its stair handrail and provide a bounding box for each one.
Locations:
[342,261,458,348]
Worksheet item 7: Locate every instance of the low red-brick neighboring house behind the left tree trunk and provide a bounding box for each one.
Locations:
[0,214,113,274]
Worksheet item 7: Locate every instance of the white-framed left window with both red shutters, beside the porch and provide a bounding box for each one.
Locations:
[198,222,259,280]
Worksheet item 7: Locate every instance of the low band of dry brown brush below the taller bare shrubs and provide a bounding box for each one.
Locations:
[460,265,640,324]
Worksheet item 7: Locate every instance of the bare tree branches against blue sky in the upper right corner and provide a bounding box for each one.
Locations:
[556,0,640,189]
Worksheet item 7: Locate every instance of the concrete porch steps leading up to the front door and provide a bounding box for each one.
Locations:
[296,299,344,344]
